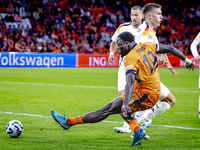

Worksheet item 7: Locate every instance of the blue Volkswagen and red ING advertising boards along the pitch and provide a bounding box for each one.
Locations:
[0,52,198,68]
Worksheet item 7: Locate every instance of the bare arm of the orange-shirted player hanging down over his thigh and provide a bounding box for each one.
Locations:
[121,72,135,118]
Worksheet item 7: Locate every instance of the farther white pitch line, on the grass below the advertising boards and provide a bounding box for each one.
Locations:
[0,81,200,93]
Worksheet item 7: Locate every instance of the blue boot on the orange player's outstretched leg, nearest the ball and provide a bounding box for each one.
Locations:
[51,110,71,130]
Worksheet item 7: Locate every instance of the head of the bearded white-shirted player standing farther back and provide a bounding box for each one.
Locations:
[131,6,144,28]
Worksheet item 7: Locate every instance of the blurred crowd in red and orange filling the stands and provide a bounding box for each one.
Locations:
[0,0,200,54]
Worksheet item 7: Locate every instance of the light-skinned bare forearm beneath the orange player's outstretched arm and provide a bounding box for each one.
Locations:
[158,54,178,76]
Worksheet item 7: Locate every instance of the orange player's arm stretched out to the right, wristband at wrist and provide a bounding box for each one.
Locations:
[156,44,195,70]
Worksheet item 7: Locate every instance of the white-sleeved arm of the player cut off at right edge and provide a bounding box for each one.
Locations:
[190,38,200,65]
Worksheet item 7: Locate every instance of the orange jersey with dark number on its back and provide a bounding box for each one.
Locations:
[124,43,161,95]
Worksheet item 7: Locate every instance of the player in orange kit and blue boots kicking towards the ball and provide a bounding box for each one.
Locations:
[51,32,194,146]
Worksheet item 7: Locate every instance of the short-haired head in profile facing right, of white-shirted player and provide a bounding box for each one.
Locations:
[142,3,163,28]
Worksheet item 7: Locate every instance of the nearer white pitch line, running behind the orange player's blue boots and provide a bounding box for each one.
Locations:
[0,111,200,130]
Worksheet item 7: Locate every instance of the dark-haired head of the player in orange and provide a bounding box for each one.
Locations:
[117,32,135,57]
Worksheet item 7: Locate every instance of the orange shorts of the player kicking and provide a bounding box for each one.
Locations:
[121,91,160,113]
